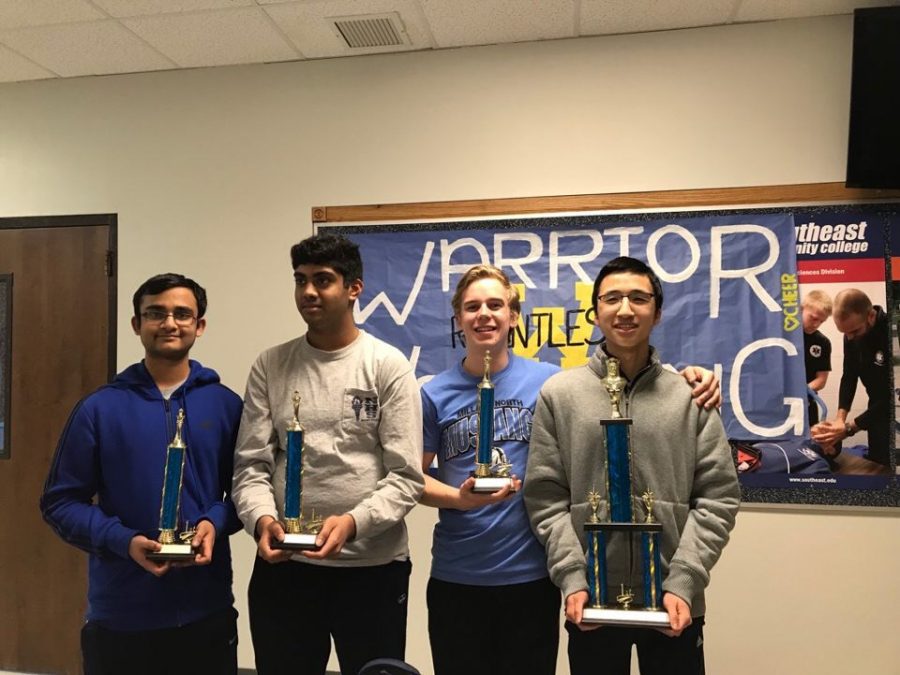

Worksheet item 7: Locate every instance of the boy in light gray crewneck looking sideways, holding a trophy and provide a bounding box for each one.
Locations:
[232,234,423,675]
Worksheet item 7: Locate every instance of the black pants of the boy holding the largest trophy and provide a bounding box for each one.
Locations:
[566,616,706,675]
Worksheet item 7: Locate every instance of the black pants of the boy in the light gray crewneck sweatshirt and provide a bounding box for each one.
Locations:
[249,558,412,675]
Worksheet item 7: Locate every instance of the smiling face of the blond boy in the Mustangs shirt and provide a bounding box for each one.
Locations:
[456,277,519,354]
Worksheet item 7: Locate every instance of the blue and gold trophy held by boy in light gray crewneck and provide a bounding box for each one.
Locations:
[272,391,322,551]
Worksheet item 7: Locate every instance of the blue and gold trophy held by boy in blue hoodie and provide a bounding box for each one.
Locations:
[147,408,197,562]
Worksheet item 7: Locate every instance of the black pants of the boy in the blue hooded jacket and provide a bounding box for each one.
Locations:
[81,607,237,675]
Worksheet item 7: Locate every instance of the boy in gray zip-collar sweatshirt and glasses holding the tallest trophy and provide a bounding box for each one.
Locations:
[524,257,740,675]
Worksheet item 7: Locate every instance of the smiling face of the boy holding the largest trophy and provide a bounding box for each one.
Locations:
[594,272,661,358]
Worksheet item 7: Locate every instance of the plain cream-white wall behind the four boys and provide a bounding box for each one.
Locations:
[0,11,900,675]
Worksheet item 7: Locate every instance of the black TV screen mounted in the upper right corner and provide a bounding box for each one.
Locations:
[847,7,900,188]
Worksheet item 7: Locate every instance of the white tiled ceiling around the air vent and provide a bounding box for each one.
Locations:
[0,0,900,82]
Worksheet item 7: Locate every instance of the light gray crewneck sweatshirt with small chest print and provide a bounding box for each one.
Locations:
[232,331,424,566]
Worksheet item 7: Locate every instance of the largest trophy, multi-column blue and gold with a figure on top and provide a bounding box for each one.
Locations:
[582,358,670,628]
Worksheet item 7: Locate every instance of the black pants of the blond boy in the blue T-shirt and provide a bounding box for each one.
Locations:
[428,579,560,675]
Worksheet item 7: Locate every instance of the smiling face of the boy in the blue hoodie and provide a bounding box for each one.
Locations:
[131,286,206,361]
